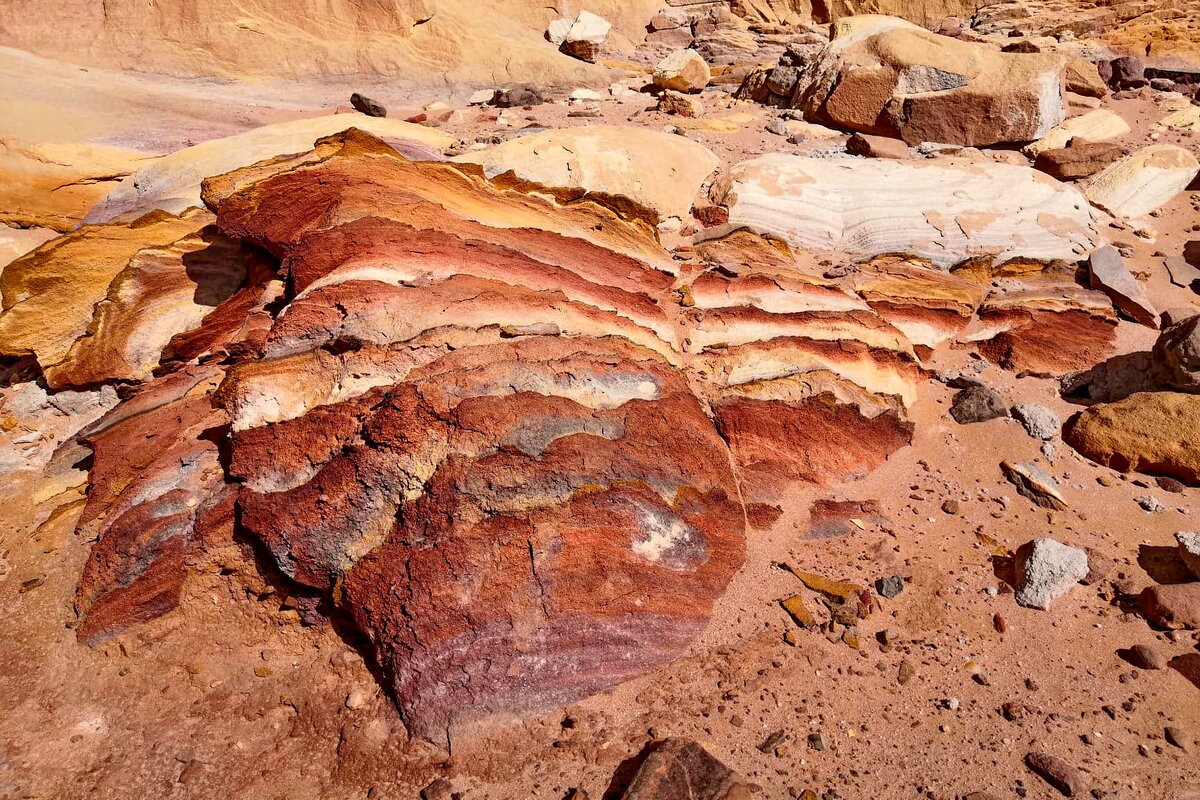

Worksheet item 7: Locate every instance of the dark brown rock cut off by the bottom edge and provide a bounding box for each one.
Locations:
[620,739,750,800]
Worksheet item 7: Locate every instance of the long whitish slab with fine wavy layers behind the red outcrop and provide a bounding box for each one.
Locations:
[703,154,1100,269]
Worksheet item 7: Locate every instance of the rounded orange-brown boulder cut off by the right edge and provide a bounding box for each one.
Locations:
[1063,392,1200,486]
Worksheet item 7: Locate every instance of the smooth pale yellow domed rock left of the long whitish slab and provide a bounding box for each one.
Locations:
[451,126,718,217]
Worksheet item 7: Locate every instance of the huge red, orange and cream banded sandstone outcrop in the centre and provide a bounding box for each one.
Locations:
[9,131,931,738]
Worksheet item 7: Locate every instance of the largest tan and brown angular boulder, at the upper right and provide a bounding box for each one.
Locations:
[791,16,1066,146]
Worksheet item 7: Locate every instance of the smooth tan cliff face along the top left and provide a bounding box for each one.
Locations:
[0,0,660,83]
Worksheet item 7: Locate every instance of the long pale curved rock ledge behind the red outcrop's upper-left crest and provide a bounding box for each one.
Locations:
[84,114,457,224]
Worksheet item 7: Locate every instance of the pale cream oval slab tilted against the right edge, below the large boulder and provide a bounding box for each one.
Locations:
[1084,144,1200,217]
